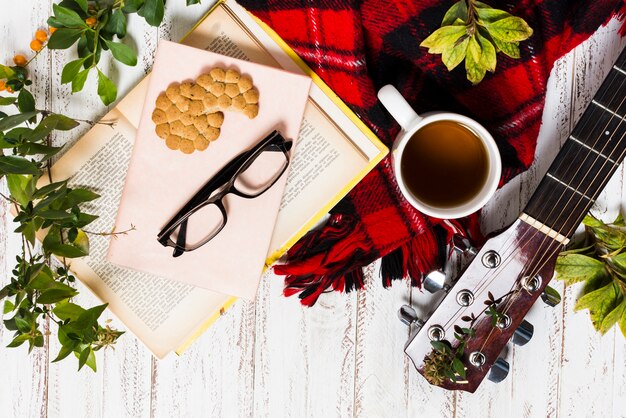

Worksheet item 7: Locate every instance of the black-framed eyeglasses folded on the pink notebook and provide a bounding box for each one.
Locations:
[157,131,293,257]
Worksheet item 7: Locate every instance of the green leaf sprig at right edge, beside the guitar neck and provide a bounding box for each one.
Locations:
[556,215,626,337]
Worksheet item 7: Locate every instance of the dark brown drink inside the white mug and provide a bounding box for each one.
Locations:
[400,120,490,208]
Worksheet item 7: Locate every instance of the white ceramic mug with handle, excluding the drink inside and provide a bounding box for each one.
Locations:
[378,85,502,219]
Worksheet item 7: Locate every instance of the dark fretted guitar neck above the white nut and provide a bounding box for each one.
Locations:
[524,49,626,237]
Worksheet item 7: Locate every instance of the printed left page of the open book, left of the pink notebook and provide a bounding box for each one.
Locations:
[45,105,230,358]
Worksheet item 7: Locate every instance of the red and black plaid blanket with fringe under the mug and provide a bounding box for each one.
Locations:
[240,0,624,306]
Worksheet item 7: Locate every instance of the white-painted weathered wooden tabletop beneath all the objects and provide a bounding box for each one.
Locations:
[0,0,626,418]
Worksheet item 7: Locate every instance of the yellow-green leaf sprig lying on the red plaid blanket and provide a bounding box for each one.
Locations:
[420,0,533,84]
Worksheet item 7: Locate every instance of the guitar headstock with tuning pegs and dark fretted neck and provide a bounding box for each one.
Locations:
[399,49,626,392]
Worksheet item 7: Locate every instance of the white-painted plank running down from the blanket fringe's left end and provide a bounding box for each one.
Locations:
[254,275,357,417]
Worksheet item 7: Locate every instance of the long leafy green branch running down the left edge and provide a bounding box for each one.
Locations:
[0,55,123,371]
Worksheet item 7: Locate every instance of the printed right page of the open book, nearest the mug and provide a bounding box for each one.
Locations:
[183,4,368,258]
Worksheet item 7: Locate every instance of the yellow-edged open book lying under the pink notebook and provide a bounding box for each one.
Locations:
[47,1,388,358]
